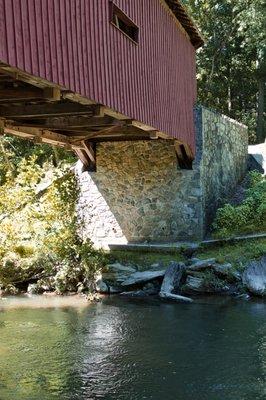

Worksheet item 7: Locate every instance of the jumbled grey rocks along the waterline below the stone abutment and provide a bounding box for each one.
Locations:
[96,256,266,302]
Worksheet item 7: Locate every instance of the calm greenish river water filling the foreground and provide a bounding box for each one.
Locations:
[0,297,266,400]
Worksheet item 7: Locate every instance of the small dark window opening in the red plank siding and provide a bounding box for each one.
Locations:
[110,2,139,43]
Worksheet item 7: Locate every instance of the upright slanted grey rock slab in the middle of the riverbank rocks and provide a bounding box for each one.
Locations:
[160,261,185,293]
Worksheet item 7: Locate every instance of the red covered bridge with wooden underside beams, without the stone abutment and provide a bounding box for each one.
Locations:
[0,0,203,168]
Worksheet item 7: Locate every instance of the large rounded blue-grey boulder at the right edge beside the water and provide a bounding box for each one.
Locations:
[242,256,266,296]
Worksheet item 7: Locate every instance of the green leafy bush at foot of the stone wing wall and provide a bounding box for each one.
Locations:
[213,172,266,237]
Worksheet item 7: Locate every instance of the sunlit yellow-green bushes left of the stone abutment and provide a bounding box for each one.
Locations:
[0,148,105,293]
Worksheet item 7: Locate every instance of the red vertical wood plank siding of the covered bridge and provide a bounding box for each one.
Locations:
[0,0,196,149]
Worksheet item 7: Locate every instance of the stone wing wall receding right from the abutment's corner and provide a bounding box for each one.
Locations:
[194,107,248,230]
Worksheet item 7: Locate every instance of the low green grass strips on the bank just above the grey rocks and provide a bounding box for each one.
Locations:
[108,238,266,270]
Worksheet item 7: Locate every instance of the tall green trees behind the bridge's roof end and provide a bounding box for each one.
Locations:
[184,0,266,142]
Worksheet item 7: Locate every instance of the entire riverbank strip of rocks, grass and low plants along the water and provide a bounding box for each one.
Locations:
[0,239,266,302]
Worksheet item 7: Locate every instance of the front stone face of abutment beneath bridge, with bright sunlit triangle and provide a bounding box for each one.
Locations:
[76,140,202,246]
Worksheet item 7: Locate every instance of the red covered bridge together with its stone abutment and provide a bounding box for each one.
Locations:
[0,0,247,246]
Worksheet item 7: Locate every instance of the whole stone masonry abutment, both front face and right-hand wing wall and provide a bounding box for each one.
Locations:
[76,107,248,247]
